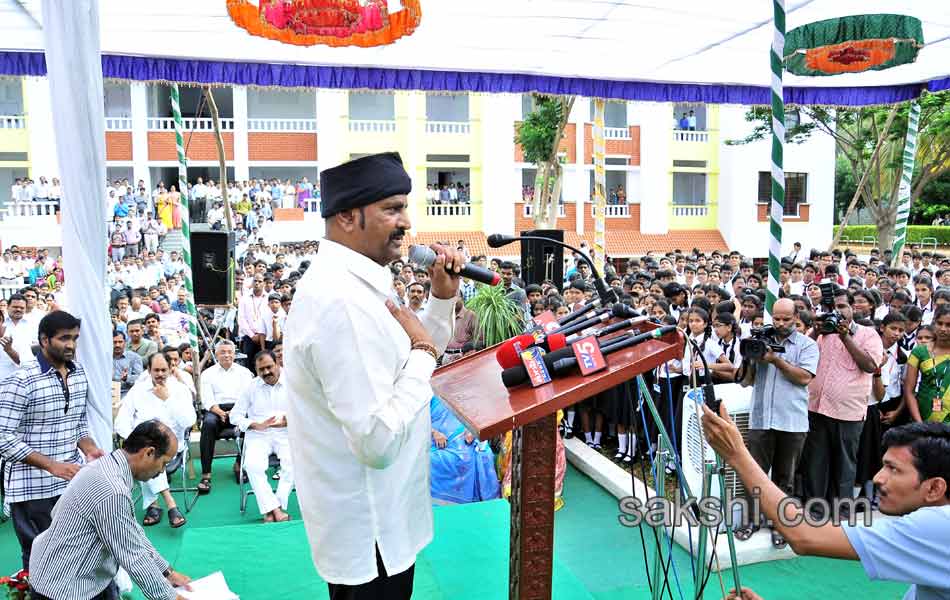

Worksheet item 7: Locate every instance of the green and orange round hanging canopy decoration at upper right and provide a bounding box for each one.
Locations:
[784,15,924,76]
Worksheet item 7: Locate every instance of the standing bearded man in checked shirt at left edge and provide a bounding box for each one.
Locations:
[0,311,103,569]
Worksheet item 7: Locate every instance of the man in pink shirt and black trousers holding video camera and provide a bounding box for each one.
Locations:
[802,280,884,519]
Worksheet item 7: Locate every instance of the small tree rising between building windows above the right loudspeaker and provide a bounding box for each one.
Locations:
[515,94,574,229]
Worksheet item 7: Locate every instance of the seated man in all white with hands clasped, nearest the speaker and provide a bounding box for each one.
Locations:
[231,350,294,523]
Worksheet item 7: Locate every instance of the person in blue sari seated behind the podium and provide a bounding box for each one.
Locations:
[429,396,500,504]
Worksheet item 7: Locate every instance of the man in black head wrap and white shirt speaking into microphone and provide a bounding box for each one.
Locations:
[284,153,463,600]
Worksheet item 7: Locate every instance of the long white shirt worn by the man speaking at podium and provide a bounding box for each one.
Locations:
[284,239,455,585]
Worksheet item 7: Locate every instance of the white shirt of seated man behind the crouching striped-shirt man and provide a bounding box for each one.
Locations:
[115,376,197,449]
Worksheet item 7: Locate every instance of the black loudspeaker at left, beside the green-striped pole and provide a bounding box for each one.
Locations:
[191,224,235,306]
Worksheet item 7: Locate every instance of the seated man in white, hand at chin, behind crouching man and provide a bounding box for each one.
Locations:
[115,352,195,528]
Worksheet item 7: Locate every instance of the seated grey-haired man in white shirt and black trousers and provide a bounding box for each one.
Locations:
[198,340,254,494]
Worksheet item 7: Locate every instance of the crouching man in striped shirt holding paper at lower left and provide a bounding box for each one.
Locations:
[30,420,191,600]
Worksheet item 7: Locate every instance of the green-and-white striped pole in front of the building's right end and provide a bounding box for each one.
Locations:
[765,0,785,321]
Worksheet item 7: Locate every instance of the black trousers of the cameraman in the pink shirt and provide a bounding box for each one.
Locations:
[802,412,864,516]
